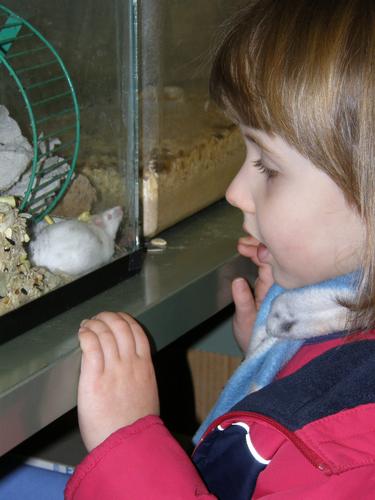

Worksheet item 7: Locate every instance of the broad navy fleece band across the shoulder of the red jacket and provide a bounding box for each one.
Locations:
[233,337,375,431]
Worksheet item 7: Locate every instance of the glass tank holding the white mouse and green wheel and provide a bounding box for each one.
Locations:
[0,0,142,336]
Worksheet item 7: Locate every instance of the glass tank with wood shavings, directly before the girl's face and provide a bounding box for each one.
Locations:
[139,0,247,236]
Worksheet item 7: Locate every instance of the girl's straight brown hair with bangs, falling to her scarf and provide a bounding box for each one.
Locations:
[210,0,375,327]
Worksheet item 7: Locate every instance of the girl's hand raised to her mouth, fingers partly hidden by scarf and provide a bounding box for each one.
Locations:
[232,236,274,354]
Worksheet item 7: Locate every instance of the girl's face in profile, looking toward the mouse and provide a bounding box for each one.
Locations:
[226,126,364,288]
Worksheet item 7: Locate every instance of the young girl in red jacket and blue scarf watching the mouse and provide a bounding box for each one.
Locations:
[66,0,375,500]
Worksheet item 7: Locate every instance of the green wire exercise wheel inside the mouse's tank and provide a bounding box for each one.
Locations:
[0,4,80,221]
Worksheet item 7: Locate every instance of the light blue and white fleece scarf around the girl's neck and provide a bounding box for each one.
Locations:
[193,272,359,443]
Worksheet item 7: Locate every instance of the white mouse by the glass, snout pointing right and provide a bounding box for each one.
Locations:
[29,207,123,275]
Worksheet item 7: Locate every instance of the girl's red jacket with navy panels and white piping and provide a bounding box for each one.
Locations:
[65,332,375,500]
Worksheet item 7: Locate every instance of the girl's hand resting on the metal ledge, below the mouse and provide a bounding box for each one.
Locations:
[78,312,159,451]
